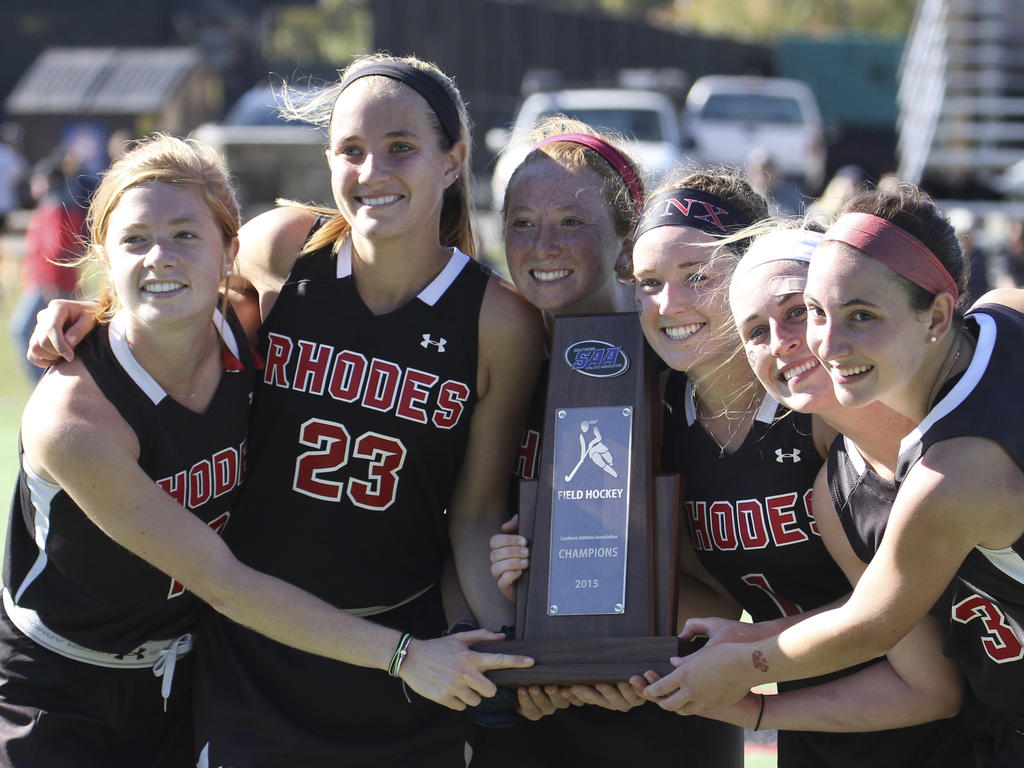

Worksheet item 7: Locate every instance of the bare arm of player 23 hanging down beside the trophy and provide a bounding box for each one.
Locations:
[449,276,544,629]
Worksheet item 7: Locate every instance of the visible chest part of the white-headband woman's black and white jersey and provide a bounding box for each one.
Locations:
[828,435,896,563]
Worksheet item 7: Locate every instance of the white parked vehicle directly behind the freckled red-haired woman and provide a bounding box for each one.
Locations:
[486,88,686,210]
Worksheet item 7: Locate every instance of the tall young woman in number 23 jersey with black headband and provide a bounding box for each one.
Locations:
[18,55,542,766]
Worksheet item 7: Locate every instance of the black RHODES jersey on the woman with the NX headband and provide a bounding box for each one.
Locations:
[663,372,850,622]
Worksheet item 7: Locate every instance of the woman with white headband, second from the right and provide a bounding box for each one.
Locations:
[638,223,971,766]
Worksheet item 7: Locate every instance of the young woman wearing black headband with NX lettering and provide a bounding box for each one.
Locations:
[493,172,864,765]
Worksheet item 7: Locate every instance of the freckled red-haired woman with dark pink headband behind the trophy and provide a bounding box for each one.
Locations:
[472,118,742,768]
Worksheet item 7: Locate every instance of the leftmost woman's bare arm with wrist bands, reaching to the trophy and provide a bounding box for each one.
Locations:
[23,361,530,710]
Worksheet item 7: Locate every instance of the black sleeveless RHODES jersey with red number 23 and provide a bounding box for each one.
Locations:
[228,241,489,609]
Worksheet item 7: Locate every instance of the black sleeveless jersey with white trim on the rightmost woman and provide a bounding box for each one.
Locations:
[896,305,1024,720]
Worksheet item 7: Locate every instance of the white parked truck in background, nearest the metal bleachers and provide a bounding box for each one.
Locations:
[684,75,825,193]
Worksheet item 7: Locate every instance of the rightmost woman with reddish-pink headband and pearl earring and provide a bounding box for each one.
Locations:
[647,185,1024,766]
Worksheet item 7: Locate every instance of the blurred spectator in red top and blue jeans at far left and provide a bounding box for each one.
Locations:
[10,163,85,381]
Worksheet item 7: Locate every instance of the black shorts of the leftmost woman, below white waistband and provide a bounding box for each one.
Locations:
[0,607,195,768]
